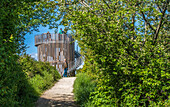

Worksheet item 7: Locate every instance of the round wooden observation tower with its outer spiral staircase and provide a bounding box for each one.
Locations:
[35,32,82,74]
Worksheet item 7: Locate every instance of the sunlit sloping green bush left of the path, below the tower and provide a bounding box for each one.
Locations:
[20,56,61,100]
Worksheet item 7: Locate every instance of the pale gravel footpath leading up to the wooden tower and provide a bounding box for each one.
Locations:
[36,77,77,107]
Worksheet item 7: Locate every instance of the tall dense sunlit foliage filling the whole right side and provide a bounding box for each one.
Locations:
[56,0,170,106]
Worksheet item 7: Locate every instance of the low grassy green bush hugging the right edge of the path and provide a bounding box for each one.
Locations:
[73,73,96,106]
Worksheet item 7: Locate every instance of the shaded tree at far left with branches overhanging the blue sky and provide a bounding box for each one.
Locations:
[0,0,57,107]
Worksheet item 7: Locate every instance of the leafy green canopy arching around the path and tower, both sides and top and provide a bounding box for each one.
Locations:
[0,0,170,106]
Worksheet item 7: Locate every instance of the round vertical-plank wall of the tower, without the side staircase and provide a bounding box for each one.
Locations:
[35,33,75,72]
